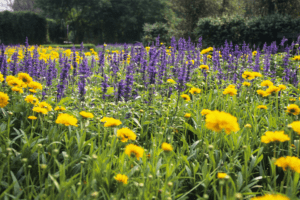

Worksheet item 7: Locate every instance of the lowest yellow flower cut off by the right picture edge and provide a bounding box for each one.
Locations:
[275,156,300,173]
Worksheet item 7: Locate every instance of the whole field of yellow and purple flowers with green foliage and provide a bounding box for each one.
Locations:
[0,38,300,200]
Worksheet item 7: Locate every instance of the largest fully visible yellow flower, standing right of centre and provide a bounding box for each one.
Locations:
[205,110,240,134]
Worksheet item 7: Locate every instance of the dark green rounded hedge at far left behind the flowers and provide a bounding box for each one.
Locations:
[0,11,47,45]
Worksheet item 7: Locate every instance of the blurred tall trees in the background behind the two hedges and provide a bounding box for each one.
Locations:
[1,0,300,44]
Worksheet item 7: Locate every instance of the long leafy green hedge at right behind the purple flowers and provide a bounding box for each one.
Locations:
[194,14,300,47]
